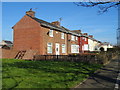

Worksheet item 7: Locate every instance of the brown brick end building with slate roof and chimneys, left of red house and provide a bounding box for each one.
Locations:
[12,10,79,55]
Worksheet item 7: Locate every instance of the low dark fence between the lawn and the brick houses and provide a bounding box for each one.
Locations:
[33,55,101,63]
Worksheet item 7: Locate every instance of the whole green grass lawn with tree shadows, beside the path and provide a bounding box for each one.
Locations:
[2,59,101,89]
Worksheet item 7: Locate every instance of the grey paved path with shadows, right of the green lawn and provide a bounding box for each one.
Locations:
[75,56,120,90]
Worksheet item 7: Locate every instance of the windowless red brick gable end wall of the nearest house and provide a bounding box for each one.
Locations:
[13,15,43,55]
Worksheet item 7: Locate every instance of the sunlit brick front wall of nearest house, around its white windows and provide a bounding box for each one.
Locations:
[41,27,68,55]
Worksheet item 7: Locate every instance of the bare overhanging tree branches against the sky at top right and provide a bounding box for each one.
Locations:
[74,0,120,14]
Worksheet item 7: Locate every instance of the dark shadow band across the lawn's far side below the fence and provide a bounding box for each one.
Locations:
[3,61,98,75]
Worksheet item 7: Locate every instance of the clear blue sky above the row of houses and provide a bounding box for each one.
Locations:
[2,2,118,44]
